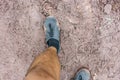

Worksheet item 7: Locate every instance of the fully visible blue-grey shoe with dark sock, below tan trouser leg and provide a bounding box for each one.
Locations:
[44,16,60,52]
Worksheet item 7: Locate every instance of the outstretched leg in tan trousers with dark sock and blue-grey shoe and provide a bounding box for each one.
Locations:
[25,17,60,80]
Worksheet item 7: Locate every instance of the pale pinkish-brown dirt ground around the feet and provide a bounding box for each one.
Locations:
[0,0,120,80]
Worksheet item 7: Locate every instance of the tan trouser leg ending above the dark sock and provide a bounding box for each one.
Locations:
[25,47,60,80]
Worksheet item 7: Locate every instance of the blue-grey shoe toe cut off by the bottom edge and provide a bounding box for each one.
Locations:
[74,69,91,80]
